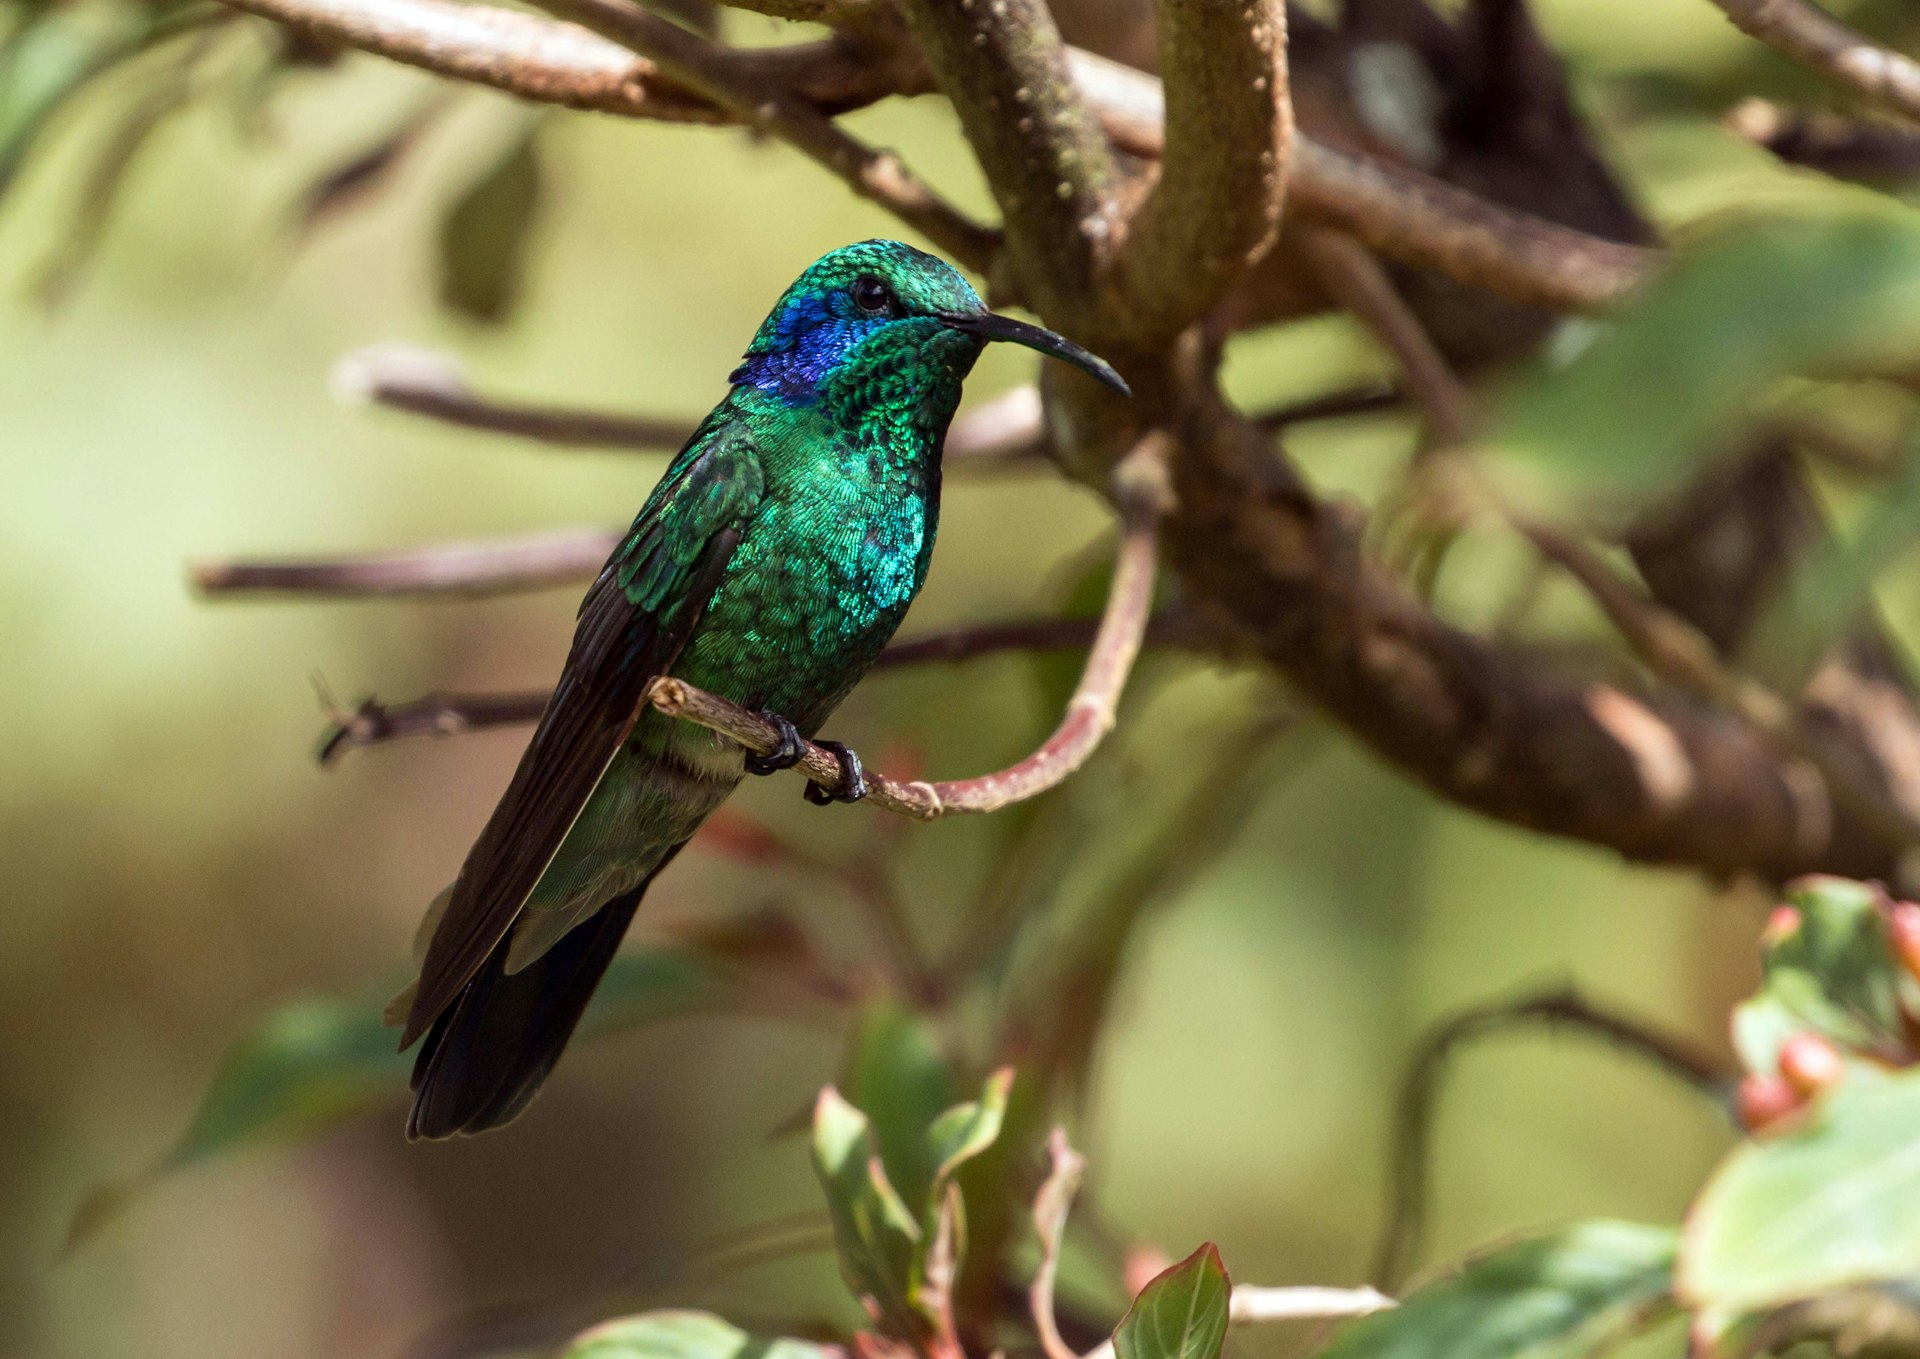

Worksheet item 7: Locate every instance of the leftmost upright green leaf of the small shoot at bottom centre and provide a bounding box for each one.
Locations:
[814,1086,924,1336]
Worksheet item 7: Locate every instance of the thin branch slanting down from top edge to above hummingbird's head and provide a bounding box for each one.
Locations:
[543,0,1000,271]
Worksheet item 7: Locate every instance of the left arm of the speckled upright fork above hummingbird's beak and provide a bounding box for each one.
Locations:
[900,0,1117,328]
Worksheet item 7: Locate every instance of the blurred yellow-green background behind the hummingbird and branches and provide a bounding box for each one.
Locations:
[0,0,1873,1359]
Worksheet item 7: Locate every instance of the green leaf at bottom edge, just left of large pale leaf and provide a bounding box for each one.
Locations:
[1321,1221,1676,1359]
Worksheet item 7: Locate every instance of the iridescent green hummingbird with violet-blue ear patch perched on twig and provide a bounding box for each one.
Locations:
[388,240,1127,1138]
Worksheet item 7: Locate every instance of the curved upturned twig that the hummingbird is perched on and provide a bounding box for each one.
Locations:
[651,432,1171,822]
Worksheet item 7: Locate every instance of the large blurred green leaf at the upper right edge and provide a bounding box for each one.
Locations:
[1488,207,1920,495]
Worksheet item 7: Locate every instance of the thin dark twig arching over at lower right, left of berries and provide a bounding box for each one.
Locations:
[1373,990,1738,1288]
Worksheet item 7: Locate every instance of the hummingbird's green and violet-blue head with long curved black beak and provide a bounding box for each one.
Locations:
[732,240,1127,415]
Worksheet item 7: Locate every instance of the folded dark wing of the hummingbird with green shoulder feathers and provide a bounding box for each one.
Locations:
[401,413,764,1048]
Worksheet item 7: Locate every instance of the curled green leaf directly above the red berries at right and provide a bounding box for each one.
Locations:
[1734,877,1907,1071]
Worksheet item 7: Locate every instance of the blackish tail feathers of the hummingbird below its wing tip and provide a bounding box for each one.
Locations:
[407,879,651,1138]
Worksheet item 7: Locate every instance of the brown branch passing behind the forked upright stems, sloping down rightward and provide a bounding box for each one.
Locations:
[1068,50,1659,311]
